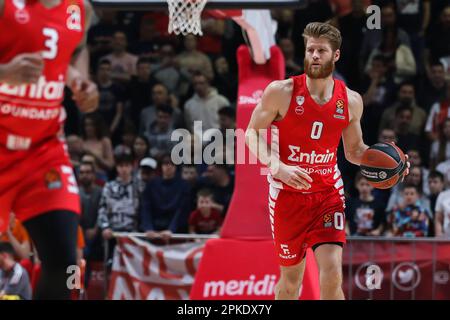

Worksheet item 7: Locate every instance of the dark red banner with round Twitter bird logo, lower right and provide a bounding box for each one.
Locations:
[343,239,450,300]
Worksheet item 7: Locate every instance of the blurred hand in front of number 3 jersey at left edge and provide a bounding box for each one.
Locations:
[1,52,44,85]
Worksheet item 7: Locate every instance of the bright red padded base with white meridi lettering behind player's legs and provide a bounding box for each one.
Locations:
[191,239,319,300]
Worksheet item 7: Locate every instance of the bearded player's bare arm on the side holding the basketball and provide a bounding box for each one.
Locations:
[342,88,369,166]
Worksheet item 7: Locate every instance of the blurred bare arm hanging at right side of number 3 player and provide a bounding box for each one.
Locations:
[66,0,99,112]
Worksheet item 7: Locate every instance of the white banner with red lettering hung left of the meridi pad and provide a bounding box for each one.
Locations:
[108,237,204,300]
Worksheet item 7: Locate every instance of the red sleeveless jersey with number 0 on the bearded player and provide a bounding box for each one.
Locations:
[268,74,349,194]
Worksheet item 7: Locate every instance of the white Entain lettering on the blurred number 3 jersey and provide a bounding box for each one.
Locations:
[0,75,65,100]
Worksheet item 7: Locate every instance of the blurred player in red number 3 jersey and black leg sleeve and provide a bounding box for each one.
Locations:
[0,0,98,299]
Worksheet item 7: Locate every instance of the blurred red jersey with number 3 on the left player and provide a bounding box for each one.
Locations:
[0,0,85,151]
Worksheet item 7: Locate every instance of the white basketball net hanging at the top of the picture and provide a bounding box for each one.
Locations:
[167,0,208,36]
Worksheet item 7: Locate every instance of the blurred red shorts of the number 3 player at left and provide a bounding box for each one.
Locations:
[0,138,80,232]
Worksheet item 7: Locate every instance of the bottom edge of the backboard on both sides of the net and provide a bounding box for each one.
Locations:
[91,0,307,10]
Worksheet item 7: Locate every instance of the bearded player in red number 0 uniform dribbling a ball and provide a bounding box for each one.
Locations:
[246,22,408,299]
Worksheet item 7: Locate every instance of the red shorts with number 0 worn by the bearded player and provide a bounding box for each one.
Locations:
[269,186,345,266]
